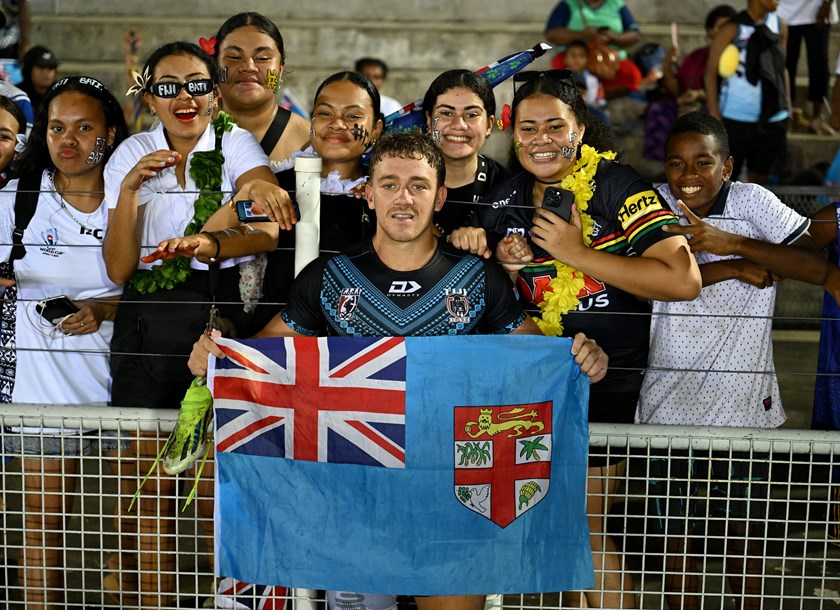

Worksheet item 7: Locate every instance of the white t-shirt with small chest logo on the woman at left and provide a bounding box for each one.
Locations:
[0,172,122,405]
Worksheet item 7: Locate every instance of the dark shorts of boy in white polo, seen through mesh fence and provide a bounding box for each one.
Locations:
[648,451,770,534]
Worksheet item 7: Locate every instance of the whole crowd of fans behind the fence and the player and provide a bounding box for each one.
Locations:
[0,0,840,610]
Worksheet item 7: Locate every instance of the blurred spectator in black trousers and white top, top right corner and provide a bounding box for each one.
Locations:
[777,0,839,135]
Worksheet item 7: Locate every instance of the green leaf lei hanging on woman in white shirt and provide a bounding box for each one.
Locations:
[129,112,234,294]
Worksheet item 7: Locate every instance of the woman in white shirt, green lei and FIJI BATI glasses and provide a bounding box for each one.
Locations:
[104,42,294,608]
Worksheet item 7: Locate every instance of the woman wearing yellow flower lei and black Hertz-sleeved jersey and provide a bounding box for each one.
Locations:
[452,71,701,608]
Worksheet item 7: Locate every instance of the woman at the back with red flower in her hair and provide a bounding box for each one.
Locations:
[213,12,309,162]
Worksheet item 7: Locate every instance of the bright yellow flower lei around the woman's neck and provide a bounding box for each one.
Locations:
[534,144,615,337]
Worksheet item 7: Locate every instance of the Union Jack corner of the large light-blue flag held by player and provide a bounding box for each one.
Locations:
[212,337,406,468]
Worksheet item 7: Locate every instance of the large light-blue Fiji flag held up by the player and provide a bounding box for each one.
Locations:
[210,335,594,595]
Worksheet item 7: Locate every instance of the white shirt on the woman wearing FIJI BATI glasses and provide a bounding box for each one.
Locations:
[105,120,270,270]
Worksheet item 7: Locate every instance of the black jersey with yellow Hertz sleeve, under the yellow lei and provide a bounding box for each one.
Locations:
[471,160,677,392]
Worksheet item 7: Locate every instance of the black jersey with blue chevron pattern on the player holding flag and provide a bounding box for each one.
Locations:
[281,241,525,337]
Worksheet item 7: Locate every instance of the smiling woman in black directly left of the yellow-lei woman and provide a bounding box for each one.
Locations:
[423,70,510,235]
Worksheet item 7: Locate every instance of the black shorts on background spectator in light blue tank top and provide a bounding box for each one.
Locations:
[723,119,788,175]
